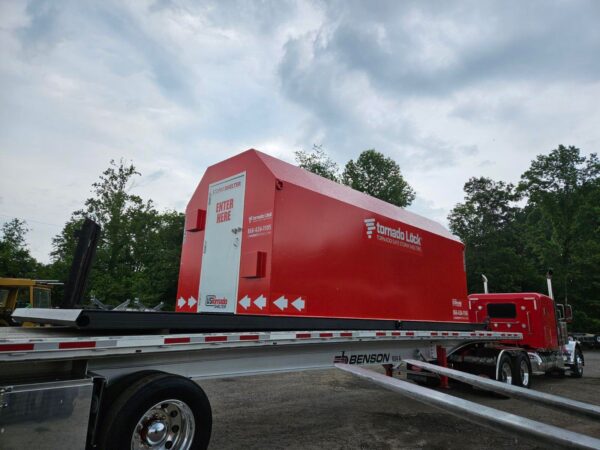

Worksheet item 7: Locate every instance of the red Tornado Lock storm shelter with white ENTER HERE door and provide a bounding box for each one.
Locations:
[176,150,469,322]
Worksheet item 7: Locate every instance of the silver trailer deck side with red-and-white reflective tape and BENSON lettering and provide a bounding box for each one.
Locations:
[0,328,522,382]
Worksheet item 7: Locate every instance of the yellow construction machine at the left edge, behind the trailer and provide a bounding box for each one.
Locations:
[0,278,62,326]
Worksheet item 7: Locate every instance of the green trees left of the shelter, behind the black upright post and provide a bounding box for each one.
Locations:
[52,161,183,305]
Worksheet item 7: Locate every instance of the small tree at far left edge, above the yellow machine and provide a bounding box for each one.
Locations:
[0,218,40,278]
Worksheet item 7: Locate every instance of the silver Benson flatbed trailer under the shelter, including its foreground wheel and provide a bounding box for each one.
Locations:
[0,311,600,450]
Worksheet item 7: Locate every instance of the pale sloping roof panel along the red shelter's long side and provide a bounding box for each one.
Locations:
[248,149,460,242]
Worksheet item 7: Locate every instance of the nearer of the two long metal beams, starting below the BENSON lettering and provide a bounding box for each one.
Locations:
[335,364,600,450]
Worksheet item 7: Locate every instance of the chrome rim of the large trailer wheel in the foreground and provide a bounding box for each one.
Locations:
[131,399,196,450]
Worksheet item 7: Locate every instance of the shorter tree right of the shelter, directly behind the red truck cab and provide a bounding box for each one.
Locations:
[448,177,543,292]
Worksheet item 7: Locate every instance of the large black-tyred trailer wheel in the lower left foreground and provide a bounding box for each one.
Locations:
[98,373,212,450]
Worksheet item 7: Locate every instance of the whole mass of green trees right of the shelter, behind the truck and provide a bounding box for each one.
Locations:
[448,145,600,331]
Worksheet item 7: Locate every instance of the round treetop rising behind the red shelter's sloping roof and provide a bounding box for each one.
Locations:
[342,149,415,207]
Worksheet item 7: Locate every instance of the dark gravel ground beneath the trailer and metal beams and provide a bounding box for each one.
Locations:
[201,351,600,449]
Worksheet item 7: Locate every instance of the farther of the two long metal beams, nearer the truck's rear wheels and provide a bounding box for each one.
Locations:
[404,359,600,419]
